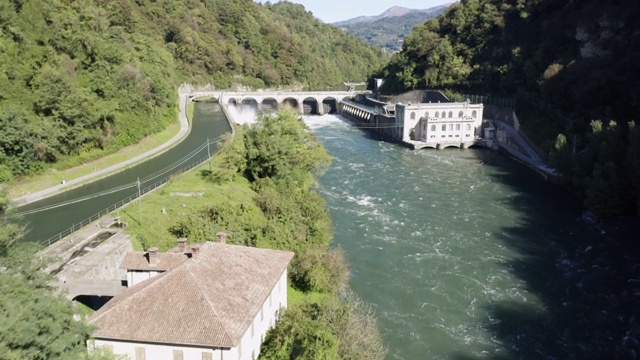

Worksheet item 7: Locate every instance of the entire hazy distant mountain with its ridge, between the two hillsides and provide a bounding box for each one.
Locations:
[331,4,451,52]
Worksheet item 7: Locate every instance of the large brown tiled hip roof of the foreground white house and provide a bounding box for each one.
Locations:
[90,242,293,347]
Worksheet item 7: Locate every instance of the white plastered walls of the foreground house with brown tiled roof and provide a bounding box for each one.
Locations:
[94,269,287,360]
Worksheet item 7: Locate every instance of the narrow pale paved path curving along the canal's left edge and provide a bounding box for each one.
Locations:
[12,91,191,206]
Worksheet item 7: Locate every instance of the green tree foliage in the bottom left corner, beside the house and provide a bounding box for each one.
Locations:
[0,193,102,360]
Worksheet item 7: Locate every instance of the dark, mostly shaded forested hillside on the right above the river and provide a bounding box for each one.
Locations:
[377,0,640,214]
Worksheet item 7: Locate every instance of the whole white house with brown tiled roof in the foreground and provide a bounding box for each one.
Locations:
[89,239,294,360]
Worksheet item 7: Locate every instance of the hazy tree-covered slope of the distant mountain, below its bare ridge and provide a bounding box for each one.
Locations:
[340,8,445,53]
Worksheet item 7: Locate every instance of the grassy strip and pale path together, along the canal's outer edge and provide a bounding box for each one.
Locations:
[9,92,191,206]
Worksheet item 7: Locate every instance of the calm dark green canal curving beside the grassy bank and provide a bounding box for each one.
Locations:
[17,101,231,242]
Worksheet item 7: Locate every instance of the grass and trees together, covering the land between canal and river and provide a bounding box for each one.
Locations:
[121,111,385,359]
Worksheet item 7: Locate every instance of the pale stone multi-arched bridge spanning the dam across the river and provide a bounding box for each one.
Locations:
[189,91,366,115]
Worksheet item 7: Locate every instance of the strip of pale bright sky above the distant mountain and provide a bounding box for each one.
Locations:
[258,0,455,23]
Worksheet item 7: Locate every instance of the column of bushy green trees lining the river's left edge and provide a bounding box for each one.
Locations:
[229,111,385,360]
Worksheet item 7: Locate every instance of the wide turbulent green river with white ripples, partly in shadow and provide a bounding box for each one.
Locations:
[305,116,640,360]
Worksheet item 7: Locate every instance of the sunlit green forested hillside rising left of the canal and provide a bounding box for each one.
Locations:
[0,0,381,183]
